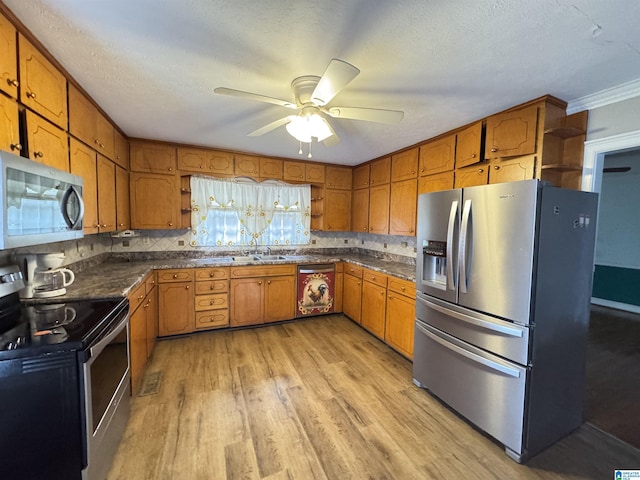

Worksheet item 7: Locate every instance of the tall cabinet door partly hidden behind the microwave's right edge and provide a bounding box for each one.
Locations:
[69,137,98,235]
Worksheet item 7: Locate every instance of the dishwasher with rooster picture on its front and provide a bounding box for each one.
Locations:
[296,264,335,317]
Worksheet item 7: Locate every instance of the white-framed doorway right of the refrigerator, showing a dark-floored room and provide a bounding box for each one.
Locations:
[582,131,640,449]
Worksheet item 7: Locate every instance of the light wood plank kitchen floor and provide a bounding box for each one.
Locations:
[108,315,640,480]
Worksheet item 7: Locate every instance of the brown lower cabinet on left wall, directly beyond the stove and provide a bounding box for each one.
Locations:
[128,272,158,395]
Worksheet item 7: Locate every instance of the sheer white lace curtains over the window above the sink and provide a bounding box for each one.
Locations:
[191,176,311,247]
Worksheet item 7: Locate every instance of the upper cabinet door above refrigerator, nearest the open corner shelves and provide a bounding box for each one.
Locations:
[484,105,538,159]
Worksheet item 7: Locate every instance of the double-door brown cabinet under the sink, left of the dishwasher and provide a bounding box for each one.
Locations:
[229,265,296,327]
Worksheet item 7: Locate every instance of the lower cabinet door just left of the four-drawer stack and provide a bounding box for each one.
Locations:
[157,282,195,337]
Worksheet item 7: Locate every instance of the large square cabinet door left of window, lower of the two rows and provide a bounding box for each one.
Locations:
[130,172,180,230]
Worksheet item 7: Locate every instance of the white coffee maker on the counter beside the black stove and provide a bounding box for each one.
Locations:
[16,253,75,298]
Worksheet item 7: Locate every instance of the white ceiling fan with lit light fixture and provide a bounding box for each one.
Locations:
[214,58,404,158]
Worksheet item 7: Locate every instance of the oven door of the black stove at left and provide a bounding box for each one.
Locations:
[82,309,131,479]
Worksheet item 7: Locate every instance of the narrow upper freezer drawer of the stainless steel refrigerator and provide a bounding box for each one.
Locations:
[416,292,529,365]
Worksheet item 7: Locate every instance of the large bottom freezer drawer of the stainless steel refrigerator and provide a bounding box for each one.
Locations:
[413,321,528,458]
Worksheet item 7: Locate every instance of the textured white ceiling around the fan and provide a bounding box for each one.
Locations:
[3,0,640,165]
